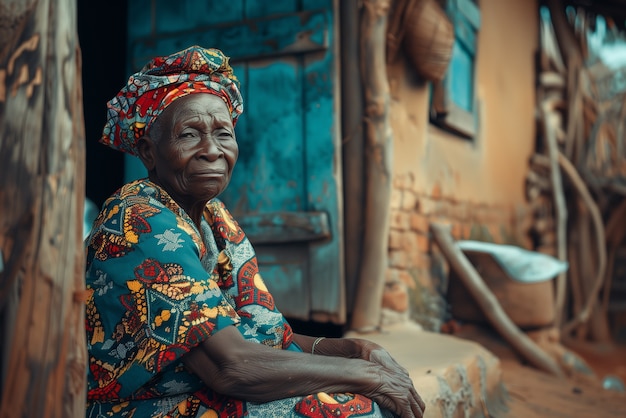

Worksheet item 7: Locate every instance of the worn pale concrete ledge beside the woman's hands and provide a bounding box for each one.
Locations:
[346,323,507,418]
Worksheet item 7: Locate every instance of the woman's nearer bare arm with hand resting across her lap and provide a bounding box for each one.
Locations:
[183,326,424,418]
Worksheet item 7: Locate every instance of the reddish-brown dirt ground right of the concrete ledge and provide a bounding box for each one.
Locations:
[455,326,626,418]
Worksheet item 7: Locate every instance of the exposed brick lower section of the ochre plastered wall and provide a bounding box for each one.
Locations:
[383,173,533,331]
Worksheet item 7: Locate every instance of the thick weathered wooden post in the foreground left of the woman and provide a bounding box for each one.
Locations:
[0,0,87,418]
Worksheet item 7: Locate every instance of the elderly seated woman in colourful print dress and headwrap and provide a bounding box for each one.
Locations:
[86,46,424,418]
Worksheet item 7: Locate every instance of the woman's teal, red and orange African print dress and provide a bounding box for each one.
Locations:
[86,180,392,418]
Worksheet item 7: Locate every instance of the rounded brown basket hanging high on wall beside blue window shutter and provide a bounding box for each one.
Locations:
[402,0,454,81]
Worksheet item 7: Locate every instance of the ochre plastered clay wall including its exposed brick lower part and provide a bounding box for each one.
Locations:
[383,0,539,329]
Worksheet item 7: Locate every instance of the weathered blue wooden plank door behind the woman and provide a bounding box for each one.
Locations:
[127,0,346,324]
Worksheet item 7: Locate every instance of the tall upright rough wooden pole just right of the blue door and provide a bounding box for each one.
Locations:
[351,0,392,332]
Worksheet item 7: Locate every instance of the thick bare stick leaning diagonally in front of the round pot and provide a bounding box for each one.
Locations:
[430,223,564,377]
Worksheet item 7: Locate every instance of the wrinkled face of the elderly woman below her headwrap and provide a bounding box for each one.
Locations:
[149,93,239,208]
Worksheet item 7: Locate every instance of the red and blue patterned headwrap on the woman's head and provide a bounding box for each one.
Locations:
[100,45,243,155]
